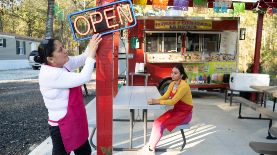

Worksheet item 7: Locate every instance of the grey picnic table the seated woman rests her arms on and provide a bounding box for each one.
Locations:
[113,86,165,150]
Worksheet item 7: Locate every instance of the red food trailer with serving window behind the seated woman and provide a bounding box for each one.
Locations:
[128,16,239,93]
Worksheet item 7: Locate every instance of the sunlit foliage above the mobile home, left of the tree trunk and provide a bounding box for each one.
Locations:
[3,0,46,37]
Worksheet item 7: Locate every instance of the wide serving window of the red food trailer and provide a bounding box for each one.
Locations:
[145,32,221,53]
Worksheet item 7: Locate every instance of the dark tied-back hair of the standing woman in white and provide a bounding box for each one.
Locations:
[34,39,55,64]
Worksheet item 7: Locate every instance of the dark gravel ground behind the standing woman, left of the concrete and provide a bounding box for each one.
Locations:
[0,69,95,155]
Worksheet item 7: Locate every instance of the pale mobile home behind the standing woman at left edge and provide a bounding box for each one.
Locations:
[0,32,40,70]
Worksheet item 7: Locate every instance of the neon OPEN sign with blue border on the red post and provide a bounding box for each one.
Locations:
[68,0,137,41]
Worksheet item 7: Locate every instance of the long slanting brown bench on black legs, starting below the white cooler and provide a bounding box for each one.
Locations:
[233,97,277,139]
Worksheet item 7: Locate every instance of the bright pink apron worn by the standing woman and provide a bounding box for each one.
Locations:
[49,86,89,153]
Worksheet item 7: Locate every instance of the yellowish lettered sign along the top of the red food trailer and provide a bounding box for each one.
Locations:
[154,20,212,30]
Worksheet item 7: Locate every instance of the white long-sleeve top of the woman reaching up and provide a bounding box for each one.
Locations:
[39,48,95,126]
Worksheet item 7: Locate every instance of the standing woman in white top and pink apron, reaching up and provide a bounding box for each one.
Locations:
[34,34,102,155]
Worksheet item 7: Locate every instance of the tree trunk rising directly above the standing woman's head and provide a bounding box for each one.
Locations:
[45,0,55,39]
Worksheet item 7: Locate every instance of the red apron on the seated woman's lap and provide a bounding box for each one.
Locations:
[156,92,193,131]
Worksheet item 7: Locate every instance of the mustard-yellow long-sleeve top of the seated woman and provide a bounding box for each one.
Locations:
[159,80,192,106]
